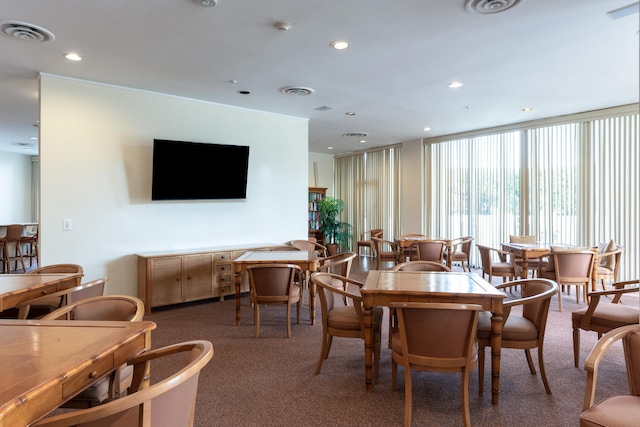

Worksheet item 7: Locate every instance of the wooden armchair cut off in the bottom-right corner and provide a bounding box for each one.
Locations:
[580,324,640,427]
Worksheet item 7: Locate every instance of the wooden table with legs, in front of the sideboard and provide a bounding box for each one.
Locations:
[233,250,322,325]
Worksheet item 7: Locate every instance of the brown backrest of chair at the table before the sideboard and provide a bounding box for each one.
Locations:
[247,264,302,302]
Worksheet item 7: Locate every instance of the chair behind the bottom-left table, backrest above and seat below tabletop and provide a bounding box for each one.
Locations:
[42,295,144,408]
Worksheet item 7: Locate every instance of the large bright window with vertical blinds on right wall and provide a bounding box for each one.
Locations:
[424,108,640,279]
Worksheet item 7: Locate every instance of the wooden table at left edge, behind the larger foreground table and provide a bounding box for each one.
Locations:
[0,273,83,311]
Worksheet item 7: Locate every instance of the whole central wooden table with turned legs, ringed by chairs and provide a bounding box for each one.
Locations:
[360,270,506,405]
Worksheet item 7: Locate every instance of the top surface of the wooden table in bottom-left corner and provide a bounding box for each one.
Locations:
[0,320,156,424]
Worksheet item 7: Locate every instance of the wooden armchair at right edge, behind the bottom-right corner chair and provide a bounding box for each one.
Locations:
[571,279,640,368]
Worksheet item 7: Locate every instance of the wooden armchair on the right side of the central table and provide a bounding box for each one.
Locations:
[478,279,558,394]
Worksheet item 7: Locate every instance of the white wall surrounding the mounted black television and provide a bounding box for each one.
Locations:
[40,75,308,295]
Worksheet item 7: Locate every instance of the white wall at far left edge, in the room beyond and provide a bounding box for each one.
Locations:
[0,152,35,225]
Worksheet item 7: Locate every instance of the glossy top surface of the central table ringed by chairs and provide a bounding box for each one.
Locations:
[360,270,506,298]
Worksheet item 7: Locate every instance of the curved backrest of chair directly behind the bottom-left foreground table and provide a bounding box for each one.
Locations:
[42,295,144,322]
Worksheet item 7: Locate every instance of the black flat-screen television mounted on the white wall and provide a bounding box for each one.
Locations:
[151,139,249,200]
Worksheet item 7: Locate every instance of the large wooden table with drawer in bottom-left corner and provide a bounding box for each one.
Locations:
[0,320,156,427]
